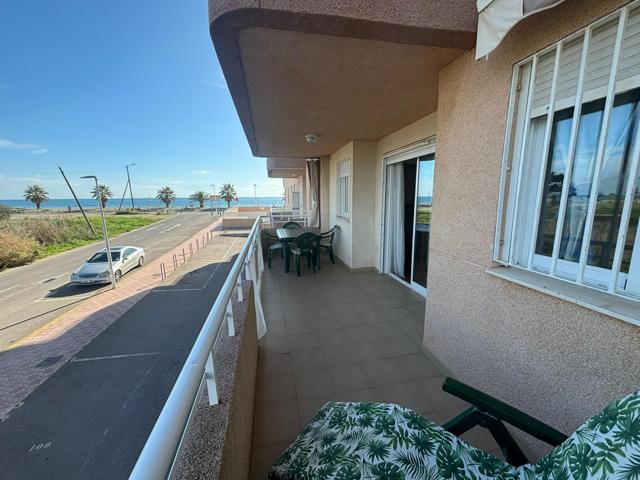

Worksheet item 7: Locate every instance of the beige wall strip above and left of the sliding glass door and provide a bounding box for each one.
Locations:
[373,112,438,270]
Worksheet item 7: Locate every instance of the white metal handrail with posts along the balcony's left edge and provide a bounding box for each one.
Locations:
[129,217,266,480]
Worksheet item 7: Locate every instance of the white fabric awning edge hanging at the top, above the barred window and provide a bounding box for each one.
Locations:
[476,0,564,60]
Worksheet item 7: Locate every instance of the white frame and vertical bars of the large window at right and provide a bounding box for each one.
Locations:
[493,1,640,300]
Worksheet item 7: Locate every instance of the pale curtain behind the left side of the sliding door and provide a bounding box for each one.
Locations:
[384,162,404,278]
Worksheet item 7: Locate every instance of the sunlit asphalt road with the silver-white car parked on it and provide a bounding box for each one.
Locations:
[0,212,219,352]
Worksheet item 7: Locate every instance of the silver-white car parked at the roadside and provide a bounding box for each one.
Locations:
[71,246,144,285]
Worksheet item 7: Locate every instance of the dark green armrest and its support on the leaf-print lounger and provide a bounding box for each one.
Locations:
[442,377,568,467]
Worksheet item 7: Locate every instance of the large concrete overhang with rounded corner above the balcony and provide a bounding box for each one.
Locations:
[209,0,477,157]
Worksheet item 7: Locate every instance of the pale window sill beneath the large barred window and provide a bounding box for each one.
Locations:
[486,267,640,326]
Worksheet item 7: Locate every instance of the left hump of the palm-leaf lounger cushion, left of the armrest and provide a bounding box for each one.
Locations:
[269,402,518,480]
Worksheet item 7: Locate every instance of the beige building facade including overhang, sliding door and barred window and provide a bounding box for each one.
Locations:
[210,0,640,449]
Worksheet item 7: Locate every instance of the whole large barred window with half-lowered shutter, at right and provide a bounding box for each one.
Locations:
[494,2,640,299]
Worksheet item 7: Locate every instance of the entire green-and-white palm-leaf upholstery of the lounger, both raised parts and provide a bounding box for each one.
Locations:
[269,393,640,480]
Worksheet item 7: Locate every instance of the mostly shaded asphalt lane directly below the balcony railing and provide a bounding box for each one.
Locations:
[0,232,246,480]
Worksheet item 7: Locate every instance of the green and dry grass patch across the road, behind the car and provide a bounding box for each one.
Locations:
[0,215,166,266]
